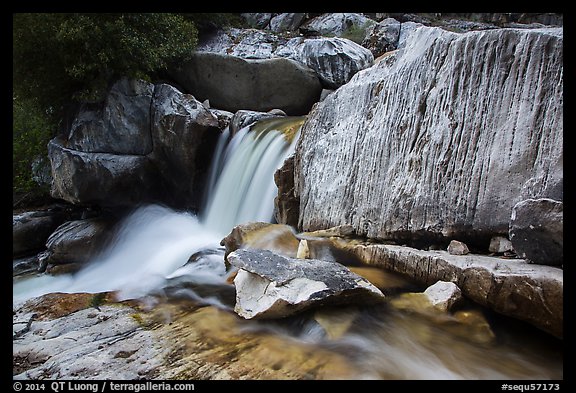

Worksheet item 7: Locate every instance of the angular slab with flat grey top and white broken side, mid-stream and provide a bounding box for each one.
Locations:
[228,249,384,319]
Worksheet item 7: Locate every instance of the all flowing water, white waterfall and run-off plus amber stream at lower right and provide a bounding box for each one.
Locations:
[13,117,563,380]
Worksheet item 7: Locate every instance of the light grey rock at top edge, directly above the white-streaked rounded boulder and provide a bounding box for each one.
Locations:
[303,12,376,43]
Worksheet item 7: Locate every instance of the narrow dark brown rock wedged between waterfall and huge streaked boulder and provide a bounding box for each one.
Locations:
[274,154,300,228]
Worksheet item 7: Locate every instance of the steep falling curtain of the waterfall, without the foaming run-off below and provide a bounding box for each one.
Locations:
[202,117,303,235]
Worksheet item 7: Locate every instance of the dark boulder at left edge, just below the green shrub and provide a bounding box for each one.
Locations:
[12,210,68,257]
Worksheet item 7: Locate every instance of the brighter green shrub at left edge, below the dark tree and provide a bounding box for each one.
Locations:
[12,98,54,196]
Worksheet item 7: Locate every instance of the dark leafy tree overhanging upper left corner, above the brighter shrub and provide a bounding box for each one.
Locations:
[13,13,197,119]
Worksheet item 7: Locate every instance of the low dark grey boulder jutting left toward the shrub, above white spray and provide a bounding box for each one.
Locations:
[48,137,160,207]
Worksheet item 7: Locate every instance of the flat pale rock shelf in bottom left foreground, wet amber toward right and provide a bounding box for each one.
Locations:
[12,294,362,381]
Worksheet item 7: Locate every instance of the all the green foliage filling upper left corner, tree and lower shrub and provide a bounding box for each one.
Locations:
[12,13,206,207]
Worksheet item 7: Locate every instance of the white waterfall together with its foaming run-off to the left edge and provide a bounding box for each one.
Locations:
[13,117,304,306]
